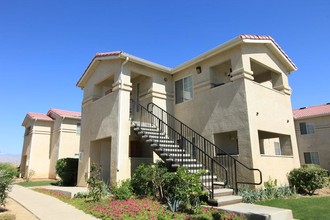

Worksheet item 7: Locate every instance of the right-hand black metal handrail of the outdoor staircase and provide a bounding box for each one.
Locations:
[147,102,262,192]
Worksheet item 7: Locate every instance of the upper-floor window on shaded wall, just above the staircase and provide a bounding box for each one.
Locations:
[175,76,192,104]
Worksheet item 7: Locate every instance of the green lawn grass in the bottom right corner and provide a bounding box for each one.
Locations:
[257,196,330,220]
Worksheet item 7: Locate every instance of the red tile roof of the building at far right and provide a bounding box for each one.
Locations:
[293,103,330,119]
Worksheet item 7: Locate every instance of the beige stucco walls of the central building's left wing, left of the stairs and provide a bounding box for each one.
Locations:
[78,60,173,185]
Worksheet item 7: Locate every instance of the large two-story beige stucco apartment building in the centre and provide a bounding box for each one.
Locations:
[77,35,300,191]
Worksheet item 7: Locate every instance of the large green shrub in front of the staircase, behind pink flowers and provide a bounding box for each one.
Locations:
[131,162,207,211]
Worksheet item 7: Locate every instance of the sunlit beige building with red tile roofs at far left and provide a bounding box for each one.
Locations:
[20,108,81,179]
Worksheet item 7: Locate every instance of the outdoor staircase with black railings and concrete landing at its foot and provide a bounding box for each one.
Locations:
[130,101,293,220]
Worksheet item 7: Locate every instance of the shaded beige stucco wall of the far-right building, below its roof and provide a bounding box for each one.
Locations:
[295,115,330,170]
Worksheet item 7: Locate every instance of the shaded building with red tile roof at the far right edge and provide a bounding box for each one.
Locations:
[293,103,330,171]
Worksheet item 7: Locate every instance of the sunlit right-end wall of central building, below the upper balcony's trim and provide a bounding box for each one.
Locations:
[246,81,299,184]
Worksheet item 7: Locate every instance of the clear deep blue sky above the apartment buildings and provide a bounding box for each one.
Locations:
[0,0,330,154]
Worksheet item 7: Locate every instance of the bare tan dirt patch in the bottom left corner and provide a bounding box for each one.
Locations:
[0,198,38,220]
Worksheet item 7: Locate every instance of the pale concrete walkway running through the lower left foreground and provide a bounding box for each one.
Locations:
[9,185,97,220]
